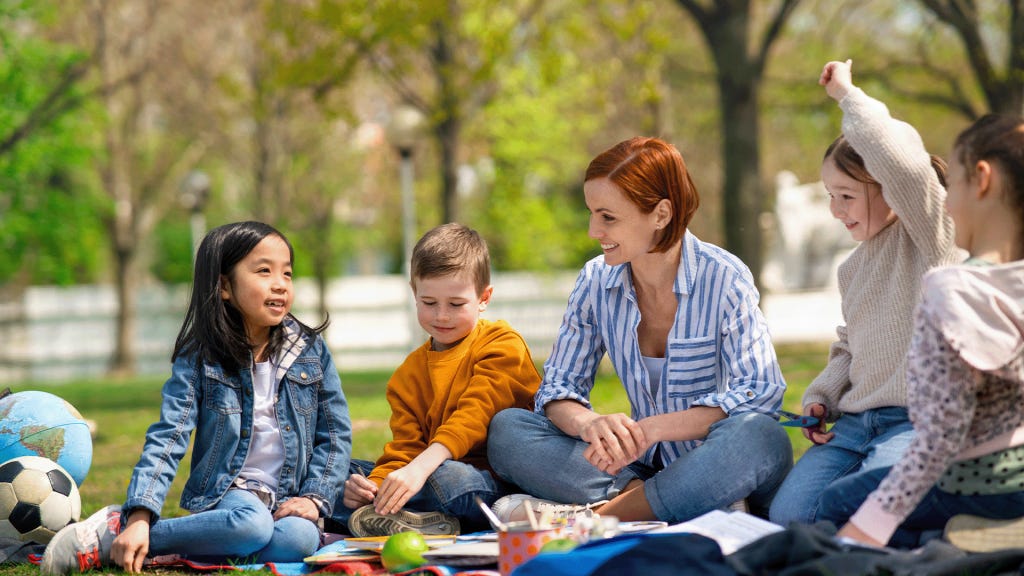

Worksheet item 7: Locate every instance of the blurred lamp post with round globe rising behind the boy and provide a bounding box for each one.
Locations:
[387,106,423,348]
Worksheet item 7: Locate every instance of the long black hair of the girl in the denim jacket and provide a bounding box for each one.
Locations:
[171,217,330,372]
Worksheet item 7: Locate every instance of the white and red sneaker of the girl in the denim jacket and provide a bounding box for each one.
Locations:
[40,504,121,575]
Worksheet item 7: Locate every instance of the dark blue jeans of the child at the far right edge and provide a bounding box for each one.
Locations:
[818,466,1024,548]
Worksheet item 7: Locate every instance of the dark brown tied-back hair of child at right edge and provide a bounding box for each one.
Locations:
[953,114,1024,227]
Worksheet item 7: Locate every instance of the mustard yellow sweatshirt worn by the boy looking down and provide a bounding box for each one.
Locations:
[370,320,541,486]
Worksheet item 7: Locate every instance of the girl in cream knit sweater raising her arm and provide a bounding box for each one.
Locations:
[771,60,963,526]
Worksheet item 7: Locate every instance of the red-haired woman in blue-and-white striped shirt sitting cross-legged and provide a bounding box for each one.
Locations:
[487,137,793,523]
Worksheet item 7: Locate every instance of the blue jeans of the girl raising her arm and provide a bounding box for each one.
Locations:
[770,406,913,526]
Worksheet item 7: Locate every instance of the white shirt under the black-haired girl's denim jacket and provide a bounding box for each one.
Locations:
[239,362,285,490]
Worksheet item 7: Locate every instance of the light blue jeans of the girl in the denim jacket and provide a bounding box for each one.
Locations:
[150,489,321,564]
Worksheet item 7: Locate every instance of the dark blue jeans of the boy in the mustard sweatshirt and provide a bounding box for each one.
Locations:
[333,458,511,532]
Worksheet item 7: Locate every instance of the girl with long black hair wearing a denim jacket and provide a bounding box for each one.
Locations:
[42,221,351,574]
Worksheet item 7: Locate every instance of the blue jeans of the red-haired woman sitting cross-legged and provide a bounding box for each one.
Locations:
[487,408,793,523]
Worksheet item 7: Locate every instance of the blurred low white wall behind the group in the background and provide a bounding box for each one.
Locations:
[0,271,841,383]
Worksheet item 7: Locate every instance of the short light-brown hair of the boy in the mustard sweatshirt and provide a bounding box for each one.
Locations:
[410,222,490,294]
